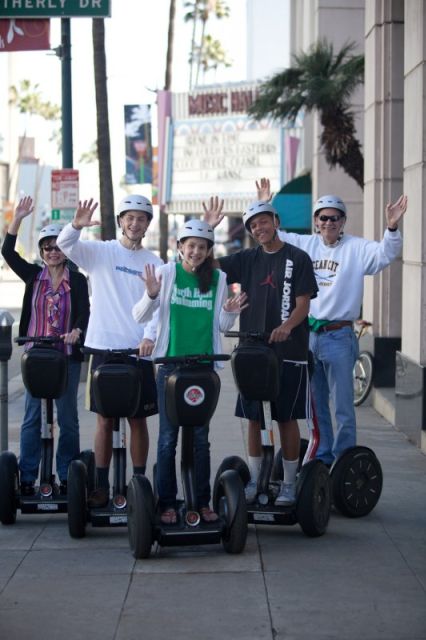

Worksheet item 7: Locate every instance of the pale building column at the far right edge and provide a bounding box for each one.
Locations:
[396,0,426,450]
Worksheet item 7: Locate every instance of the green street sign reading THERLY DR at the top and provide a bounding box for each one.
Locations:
[0,0,111,19]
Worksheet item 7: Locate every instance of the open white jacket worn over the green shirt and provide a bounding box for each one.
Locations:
[132,262,238,368]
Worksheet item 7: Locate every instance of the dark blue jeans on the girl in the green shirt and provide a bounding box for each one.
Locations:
[157,364,211,511]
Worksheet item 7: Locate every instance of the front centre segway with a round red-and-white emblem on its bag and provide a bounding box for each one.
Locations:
[127,355,247,558]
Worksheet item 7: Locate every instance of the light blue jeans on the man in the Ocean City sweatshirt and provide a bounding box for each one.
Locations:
[309,326,358,464]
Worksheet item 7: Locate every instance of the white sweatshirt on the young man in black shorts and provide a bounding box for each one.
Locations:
[58,224,162,349]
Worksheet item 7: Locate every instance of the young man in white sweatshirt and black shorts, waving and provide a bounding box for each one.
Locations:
[58,194,162,508]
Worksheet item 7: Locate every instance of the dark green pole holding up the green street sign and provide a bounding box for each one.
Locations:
[61,18,73,169]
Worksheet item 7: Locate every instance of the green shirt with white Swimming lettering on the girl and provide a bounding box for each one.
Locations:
[167,263,219,356]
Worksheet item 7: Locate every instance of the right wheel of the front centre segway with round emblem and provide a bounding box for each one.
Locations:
[213,469,248,553]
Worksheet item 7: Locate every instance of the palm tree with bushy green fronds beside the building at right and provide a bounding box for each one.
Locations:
[249,40,364,189]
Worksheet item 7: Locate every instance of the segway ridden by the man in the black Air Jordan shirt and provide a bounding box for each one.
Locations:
[213,331,331,537]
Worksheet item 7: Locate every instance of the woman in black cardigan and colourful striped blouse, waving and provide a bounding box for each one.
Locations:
[2,196,90,496]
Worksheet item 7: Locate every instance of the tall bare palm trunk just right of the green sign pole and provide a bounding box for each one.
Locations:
[92,18,116,240]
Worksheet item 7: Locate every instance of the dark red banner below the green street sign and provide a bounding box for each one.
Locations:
[0,19,50,52]
